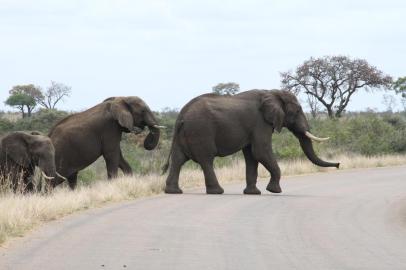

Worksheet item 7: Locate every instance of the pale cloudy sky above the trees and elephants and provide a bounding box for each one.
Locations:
[0,0,406,110]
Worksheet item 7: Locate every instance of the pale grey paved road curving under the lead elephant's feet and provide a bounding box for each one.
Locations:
[0,167,406,270]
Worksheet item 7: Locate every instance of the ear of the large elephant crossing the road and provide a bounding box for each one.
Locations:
[260,93,285,132]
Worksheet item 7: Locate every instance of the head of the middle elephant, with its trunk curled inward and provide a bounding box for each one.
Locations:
[104,97,164,150]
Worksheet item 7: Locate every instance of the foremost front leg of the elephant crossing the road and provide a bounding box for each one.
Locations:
[254,144,282,193]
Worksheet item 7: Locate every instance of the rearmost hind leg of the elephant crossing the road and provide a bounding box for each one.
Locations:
[165,146,189,194]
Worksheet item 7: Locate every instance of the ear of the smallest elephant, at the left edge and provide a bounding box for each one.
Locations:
[2,133,31,167]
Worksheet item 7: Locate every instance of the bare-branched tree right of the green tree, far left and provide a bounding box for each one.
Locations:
[37,81,72,109]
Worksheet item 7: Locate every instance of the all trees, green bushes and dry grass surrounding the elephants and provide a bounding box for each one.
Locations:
[0,56,406,244]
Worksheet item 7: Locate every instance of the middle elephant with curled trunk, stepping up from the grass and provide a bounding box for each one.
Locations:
[49,97,160,189]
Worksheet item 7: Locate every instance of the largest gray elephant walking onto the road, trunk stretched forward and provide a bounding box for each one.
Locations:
[164,90,340,194]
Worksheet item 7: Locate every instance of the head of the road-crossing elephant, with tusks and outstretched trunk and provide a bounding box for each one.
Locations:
[260,90,340,168]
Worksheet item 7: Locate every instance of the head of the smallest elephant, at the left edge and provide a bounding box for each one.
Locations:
[2,131,59,180]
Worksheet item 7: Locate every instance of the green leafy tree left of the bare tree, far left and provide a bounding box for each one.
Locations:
[5,84,42,118]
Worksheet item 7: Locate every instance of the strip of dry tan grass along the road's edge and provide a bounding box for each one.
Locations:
[0,155,406,244]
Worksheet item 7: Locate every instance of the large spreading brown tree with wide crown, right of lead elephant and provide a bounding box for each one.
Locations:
[281,56,392,118]
